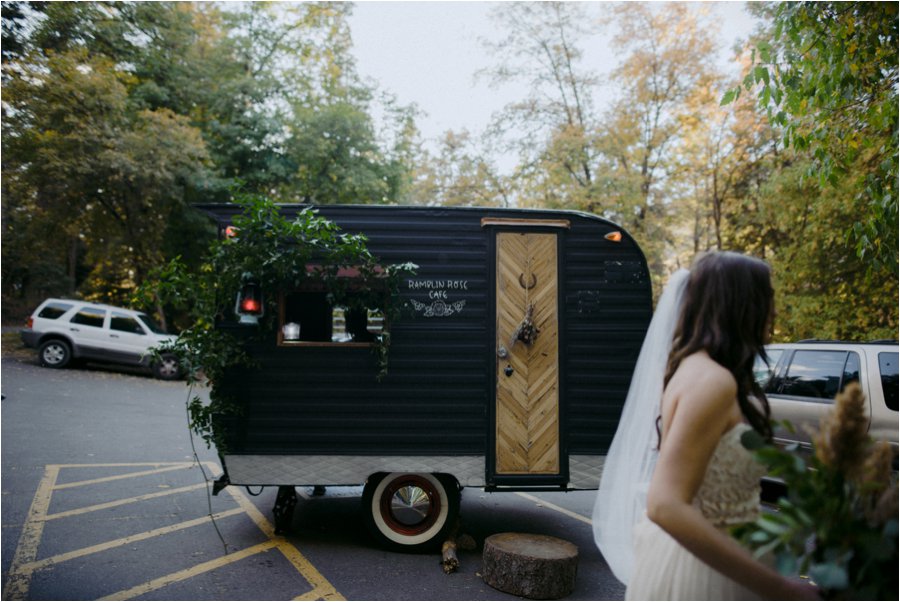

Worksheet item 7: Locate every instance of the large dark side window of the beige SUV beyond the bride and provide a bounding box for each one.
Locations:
[778,350,860,401]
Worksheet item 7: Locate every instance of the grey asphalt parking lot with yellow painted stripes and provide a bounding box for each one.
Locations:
[2,339,624,600]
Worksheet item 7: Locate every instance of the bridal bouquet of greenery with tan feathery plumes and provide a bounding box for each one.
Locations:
[735,384,898,600]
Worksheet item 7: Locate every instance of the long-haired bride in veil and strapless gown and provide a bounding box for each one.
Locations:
[593,252,818,600]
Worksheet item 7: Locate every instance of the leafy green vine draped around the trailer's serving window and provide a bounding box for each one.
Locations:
[135,196,416,453]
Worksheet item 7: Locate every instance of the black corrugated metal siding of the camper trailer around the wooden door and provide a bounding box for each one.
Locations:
[205,206,651,455]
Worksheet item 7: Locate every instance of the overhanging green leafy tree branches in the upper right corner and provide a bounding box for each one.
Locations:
[723,2,898,270]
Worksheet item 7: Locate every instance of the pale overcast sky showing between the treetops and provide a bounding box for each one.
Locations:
[350,1,764,146]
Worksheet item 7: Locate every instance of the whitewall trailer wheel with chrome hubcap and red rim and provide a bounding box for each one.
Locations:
[363,472,459,552]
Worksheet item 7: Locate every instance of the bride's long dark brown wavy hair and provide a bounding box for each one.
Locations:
[663,251,775,439]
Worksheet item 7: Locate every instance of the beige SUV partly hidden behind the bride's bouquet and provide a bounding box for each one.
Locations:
[756,341,898,450]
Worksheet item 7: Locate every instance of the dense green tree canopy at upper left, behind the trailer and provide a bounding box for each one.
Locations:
[3,1,417,314]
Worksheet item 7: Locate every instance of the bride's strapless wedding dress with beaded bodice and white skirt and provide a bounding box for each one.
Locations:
[625,423,765,600]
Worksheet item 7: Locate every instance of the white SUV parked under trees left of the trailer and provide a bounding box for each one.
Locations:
[20,299,181,380]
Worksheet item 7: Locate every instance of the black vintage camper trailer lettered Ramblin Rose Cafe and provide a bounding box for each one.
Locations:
[202,205,652,549]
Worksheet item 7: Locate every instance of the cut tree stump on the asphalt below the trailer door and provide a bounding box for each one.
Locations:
[481,533,578,600]
